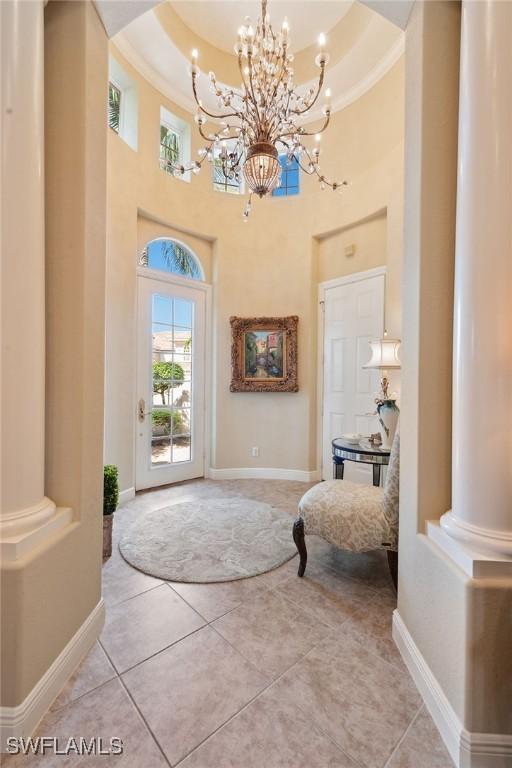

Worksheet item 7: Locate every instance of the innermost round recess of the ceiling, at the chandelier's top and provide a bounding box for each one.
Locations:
[171,0,354,53]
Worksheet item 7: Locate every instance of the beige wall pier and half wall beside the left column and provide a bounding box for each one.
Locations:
[1,2,108,707]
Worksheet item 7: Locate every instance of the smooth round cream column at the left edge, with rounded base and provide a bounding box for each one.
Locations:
[0,0,55,554]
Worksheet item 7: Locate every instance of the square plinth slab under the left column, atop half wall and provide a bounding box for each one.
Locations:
[0,504,73,563]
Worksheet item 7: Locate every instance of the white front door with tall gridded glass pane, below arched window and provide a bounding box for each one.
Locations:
[136,277,205,489]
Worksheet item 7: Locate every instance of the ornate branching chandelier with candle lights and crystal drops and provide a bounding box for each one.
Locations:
[178,0,347,220]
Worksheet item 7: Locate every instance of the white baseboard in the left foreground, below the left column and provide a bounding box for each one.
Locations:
[0,598,105,752]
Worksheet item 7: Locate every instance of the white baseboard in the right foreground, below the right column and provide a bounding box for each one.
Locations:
[393,610,512,768]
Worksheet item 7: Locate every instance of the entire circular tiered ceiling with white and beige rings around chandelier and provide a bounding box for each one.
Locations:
[113,0,404,120]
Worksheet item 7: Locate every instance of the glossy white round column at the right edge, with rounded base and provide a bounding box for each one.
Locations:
[440,0,512,560]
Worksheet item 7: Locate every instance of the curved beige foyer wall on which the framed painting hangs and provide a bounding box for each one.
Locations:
[105,45,403,489]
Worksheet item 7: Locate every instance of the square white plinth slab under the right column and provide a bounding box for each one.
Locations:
[426,518,512,579]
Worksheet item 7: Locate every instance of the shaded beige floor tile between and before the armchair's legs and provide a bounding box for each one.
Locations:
[277,563,376,627]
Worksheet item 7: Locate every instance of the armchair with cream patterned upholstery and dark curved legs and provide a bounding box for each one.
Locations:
[293,432,400,589]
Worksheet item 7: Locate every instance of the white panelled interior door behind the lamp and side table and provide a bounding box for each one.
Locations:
[320,273,384,483]
